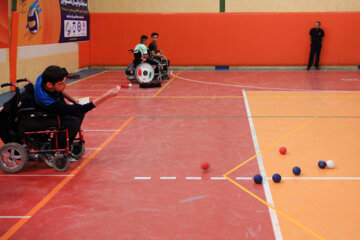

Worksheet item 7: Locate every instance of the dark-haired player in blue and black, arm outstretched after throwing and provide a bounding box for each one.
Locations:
[34,65,120,162]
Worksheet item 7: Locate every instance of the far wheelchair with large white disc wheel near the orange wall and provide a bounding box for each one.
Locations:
[125,49,168,87]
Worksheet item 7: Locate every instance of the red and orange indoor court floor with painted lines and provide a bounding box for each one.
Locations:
[0,70,360,240]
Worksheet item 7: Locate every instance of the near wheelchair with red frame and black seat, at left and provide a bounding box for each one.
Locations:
[0,79,85,173]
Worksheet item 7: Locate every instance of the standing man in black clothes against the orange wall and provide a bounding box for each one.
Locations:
[306,21,324,70]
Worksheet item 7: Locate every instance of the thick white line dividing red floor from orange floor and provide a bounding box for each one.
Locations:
[242,89,283,240]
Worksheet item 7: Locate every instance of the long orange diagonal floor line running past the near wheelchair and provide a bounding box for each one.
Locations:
[0,116,134,240]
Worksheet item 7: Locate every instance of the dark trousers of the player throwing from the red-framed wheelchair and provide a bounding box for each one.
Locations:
[59,113,85,148]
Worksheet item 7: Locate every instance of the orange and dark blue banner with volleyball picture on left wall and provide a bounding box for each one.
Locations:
[17,0,89,46]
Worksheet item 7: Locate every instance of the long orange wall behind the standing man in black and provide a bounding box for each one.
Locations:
[87,12,360,65]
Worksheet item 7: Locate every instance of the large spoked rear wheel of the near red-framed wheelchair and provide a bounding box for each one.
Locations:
[0,143,29,173]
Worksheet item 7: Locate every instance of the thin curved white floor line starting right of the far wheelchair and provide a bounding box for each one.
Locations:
[170,71,360,92]
